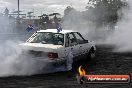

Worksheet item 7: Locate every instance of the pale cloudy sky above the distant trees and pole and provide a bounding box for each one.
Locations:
[0,0,89,14]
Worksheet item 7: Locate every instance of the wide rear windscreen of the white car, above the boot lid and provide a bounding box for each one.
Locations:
[27,32,64,45]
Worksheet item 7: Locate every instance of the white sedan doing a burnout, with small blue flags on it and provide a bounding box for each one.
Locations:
[20,29,96,70]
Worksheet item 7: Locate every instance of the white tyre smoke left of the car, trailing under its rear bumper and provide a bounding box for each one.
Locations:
[0,16,65,77]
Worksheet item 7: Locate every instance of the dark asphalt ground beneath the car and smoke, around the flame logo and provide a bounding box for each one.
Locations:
[0,45,132,88]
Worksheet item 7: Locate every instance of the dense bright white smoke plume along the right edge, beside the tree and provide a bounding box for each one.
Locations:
[107,0,132,52]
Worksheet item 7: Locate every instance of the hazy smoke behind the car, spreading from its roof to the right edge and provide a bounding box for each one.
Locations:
[63,0,132,52]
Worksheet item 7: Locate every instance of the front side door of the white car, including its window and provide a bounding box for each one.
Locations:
[74,32,90,55]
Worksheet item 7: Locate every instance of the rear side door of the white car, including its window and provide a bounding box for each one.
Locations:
[65,33,79,59]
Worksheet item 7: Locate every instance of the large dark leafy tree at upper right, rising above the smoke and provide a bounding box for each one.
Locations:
[86,0,127,25]
